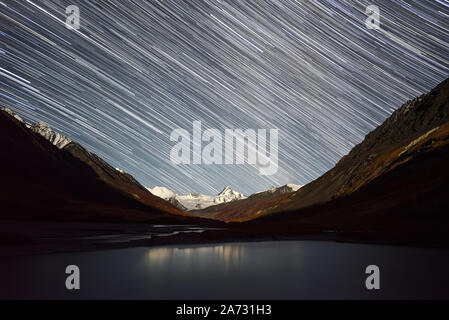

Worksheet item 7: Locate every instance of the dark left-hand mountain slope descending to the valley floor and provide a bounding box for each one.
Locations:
[0,112,194,222]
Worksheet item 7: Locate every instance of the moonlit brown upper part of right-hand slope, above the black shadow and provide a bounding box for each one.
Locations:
[188,79,449,221]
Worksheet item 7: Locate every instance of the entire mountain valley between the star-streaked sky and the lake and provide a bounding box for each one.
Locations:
[0,80,449,252]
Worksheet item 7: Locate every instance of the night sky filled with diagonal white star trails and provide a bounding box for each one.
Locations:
[0,0,449,194]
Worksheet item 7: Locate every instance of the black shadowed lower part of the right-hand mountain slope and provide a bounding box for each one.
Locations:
[242,134,449,246]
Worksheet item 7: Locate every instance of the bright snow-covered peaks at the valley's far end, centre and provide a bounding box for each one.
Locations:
[147,187,246,210]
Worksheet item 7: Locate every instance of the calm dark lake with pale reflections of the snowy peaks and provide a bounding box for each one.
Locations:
[0,241,449,299]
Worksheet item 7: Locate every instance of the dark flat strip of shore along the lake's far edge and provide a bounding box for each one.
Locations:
[0,224,449,259]
